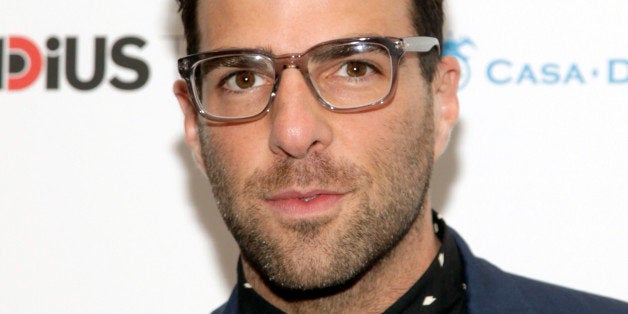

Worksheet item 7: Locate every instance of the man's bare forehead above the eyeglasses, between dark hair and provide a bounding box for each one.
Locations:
[197,0,416,54]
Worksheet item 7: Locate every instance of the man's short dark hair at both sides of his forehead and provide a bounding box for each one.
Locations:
[176,0,445,82]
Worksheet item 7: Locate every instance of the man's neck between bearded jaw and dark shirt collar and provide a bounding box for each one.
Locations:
[242,201,440,313]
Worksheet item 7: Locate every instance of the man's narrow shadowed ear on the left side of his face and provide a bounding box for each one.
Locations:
[173,80,207,175]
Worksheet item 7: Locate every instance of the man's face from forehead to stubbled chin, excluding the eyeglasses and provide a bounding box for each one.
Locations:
[182,0,457,289]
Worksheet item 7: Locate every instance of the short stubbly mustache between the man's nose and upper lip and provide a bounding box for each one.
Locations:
[245,153,369,196]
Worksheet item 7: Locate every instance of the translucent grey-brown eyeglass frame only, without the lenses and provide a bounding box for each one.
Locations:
[178,36,440,122]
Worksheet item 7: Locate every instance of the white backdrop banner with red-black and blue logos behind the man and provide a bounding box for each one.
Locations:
[0,0,628,313]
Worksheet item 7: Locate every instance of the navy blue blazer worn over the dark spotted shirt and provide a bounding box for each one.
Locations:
[212,228,628,314]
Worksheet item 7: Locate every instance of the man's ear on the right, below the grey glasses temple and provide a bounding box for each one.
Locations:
[431,57,460,161]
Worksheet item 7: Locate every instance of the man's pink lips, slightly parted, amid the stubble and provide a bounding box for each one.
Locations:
[265,190,347,221]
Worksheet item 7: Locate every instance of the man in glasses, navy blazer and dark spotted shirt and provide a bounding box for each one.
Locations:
[174,0,628,313]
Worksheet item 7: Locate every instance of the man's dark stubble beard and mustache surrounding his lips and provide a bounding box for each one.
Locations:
[200,101,434,291]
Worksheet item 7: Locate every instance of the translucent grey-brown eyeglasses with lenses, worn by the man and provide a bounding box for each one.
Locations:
[178,36,439,122]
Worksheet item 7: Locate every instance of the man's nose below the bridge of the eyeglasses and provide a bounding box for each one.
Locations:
[269,68,333,159]
